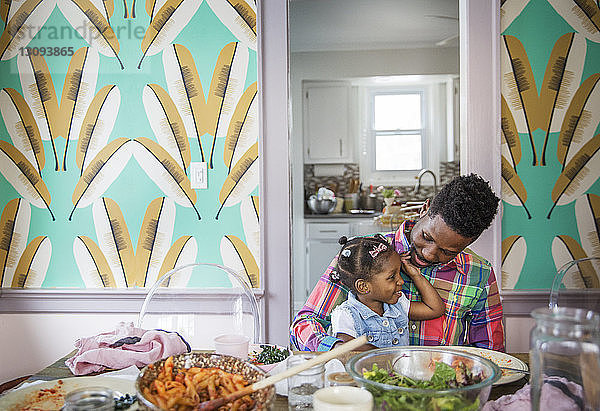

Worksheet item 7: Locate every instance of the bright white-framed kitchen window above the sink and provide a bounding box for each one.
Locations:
[352,75,458,186]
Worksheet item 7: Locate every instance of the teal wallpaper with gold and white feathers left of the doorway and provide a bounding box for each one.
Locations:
[0,0,260,288]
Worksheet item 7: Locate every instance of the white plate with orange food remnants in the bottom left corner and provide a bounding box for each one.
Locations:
[0,375,138,411]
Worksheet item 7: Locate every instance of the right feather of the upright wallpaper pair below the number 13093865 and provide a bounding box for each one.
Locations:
[59,47,100,171]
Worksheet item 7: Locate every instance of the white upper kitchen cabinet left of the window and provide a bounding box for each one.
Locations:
[303,82,354,164]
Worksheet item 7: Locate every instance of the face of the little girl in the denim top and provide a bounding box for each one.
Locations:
[366,252,404,304]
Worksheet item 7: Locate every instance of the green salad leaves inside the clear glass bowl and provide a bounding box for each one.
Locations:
[363,362,482,411]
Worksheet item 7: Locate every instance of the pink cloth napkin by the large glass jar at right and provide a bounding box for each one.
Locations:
[482,377,583,411]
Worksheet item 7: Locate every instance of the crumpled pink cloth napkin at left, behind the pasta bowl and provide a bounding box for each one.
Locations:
[65,322,190,375]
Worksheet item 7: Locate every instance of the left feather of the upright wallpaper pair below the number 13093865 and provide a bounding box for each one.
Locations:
[17,55,60,171]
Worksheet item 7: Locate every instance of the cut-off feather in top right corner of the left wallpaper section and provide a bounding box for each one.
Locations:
[207,0,256,50]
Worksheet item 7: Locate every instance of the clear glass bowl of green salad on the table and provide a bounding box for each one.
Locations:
[346,346,502,411]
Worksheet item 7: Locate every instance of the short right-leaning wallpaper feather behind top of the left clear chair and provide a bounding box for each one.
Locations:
[158,235,198,288]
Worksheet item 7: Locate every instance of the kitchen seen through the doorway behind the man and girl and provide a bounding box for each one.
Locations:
[290,1,460,312]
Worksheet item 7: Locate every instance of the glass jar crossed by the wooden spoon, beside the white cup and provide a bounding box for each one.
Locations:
[287,353,325,410]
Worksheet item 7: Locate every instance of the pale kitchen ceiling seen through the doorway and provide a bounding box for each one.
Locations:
[289,0,458,52]
